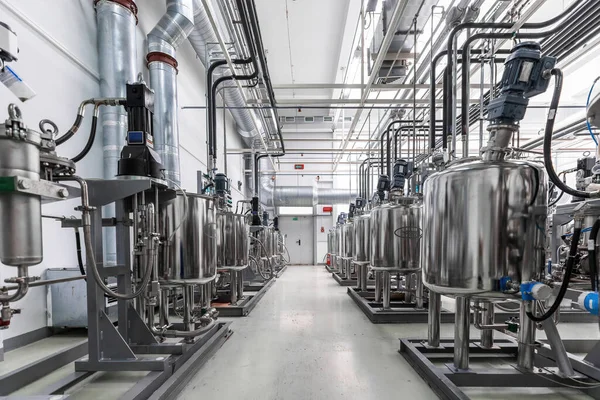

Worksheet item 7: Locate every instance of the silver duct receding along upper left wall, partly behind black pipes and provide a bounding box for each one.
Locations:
[188,0,260,144]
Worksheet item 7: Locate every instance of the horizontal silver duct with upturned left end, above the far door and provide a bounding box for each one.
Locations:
[259,159,358,208]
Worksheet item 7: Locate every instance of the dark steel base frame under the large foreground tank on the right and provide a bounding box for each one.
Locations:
[399,339,600,400]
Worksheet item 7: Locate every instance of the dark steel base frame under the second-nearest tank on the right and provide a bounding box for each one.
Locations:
[348,287,454,324]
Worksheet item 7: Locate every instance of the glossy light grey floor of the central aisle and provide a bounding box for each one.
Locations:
[180,266,437,400]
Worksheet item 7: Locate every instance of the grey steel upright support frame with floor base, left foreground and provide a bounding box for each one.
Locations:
[0,179,232,400]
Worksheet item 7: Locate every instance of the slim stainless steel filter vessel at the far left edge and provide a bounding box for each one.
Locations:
[0,107,43,266]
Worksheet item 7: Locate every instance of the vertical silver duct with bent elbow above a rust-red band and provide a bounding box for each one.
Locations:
[147,0,194,185]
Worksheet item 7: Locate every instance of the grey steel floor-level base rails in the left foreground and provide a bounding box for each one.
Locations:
[2,322,233,400]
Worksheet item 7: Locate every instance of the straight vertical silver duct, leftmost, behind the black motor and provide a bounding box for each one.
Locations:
[95,0,137,265]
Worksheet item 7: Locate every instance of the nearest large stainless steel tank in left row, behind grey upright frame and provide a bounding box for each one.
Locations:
[159,193,218,284]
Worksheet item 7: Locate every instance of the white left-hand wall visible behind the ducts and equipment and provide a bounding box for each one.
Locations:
[0,0,244,339]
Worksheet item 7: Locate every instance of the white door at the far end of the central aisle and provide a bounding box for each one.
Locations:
[279,216,314,265]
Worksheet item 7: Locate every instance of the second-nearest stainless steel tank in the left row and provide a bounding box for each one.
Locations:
[217,212,250,267]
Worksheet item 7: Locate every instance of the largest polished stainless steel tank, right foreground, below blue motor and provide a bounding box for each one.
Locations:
[423,161,547,299]
